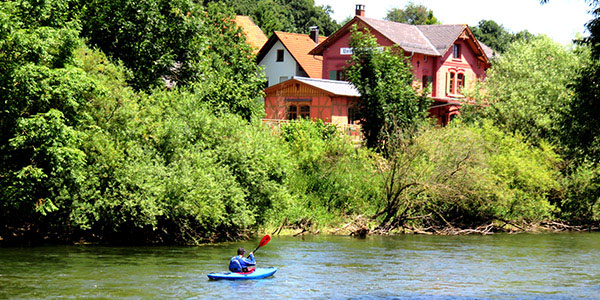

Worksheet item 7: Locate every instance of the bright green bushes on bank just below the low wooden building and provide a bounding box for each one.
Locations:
[281,120,380,222]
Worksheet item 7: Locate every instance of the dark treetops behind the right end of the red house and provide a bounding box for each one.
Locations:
[471,20,535,53]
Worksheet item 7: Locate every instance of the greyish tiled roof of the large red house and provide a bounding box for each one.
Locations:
[310,16,493,63]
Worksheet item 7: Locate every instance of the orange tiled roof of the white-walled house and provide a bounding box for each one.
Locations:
[256,31,327,78]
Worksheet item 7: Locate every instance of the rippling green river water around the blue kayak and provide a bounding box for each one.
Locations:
[0,233,600,299]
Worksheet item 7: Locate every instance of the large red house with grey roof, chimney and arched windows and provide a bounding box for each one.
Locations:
[309,5,494,124]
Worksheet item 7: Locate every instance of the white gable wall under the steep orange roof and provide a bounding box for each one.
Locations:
[258,41,306,86]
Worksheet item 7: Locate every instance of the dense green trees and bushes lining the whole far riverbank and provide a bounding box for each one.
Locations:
[0,0,600,244]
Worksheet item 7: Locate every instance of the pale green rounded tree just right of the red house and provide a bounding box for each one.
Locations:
[470,36,581,143]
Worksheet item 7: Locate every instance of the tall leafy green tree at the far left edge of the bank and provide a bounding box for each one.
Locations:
[0,1,97,234]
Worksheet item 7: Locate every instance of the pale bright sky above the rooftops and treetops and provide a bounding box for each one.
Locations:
[315,0,592,45]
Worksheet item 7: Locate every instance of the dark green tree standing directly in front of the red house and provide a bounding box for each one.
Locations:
[346,26,431,148]
